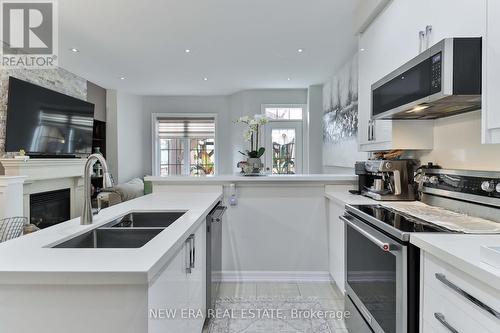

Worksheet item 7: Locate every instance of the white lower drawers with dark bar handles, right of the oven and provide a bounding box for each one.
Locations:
[420,252,500,333]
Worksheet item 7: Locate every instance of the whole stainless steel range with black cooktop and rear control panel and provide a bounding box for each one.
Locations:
[341,168,500,333]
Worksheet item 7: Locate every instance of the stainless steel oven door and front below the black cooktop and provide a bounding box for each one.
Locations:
[341,205,424,333]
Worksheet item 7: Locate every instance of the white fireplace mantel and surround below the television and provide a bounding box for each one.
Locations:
[0,158,87,218]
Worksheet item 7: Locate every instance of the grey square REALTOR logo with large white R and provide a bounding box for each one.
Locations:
[0,0,58,68]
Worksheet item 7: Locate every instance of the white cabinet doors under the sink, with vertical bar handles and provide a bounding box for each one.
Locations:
[148,222,206,333]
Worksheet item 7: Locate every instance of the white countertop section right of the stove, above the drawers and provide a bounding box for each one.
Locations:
[410,233,500,290]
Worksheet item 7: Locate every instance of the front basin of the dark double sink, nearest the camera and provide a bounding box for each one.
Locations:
[53,228,163,248]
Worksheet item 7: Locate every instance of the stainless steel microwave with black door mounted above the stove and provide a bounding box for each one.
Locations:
[371,37,482,119]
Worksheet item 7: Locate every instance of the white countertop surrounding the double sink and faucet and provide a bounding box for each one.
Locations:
[0,186,222,284]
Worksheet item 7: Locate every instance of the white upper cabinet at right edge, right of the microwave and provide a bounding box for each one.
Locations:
[482,0,500,143]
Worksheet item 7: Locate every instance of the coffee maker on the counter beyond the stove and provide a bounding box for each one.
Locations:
[355,160,417,201]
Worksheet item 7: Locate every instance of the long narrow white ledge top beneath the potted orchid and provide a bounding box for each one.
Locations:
[144,174,358,184]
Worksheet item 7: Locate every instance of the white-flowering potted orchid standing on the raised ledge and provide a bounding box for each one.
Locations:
[236,114,269,174]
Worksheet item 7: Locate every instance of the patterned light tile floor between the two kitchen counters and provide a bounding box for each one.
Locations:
[204,282,348,333]
